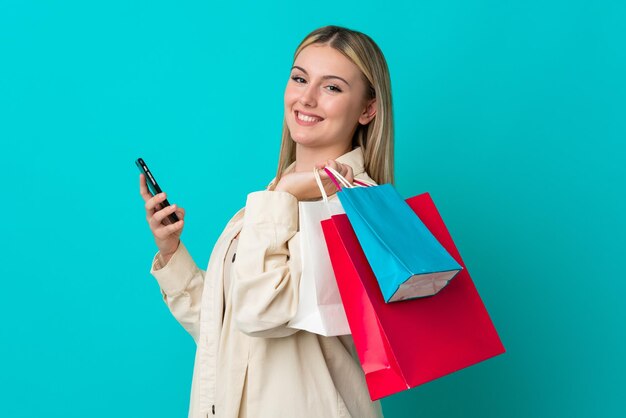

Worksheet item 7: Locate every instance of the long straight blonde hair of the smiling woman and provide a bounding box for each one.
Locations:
[276,26,394,184]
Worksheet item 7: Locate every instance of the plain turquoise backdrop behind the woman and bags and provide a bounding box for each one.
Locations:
[0,0,626,418]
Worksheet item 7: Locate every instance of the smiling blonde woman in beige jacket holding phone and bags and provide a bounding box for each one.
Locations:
[140,26,393,418]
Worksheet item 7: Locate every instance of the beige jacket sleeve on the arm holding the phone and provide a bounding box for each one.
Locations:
[150,241,205,343]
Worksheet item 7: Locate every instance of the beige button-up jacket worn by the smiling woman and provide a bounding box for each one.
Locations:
[150,148,382,418]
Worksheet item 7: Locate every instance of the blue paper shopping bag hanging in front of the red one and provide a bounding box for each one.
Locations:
[325,167,462,302]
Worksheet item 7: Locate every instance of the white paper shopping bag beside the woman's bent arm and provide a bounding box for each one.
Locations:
[287,170,369,337]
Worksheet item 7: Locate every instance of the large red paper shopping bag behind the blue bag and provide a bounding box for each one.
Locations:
[322,193,505,400]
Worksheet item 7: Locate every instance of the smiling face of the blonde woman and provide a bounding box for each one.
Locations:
[285,44,375,147]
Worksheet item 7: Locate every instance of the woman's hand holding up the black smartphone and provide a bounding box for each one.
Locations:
[139,173,185,264]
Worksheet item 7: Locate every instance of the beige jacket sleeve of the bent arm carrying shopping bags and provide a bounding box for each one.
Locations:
[231,190,301,337]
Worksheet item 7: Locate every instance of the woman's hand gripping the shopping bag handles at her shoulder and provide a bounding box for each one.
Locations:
[274,160,354,200]
